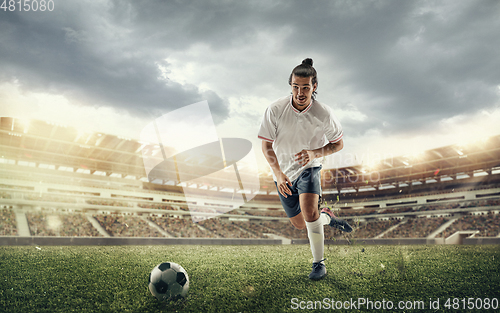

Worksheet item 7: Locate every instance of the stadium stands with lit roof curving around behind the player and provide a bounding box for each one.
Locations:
[0,117,500,244]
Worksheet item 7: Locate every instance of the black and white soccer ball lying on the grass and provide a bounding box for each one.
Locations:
[149,262,189,302]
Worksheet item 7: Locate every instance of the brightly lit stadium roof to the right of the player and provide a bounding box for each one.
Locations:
[323,136,500,189]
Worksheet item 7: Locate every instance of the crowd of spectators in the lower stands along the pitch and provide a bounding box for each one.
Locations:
[0,200,500,239]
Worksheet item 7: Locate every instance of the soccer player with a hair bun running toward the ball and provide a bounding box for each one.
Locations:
[258,59,352,280]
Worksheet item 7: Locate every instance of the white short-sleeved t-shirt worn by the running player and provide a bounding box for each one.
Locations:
[258,96,343,182]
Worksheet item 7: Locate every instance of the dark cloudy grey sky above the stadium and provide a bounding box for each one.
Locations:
[0,0,500,171]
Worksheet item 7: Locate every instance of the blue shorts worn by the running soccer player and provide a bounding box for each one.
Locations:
[274,166,321,218]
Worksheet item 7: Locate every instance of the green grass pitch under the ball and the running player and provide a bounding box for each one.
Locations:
[0,245,500,312]
